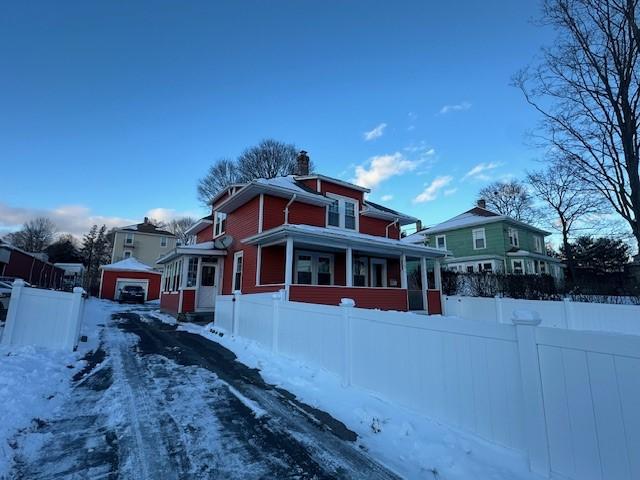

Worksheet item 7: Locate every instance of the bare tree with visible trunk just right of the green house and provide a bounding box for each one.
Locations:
[527,162,604,279]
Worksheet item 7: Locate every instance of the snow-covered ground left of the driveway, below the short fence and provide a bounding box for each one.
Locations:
[0,299,124,478]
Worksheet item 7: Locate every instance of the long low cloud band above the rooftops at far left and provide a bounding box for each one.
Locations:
[0,203,199,237]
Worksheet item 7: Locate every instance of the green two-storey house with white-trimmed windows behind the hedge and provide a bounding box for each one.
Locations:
[405,201,563,279]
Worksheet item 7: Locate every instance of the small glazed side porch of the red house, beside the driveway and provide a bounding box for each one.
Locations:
[158,242,226,315]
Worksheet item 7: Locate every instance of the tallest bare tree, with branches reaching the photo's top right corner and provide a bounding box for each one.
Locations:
[514,0,640,256]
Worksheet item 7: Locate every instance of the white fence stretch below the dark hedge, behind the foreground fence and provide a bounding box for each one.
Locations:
[442,295,640,335]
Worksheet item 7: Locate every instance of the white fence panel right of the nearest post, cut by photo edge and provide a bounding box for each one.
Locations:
[537,328,640,480]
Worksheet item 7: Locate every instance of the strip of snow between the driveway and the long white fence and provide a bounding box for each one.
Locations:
[179,324,538,480]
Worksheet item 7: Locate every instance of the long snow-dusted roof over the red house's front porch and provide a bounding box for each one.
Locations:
[242,225,446,258]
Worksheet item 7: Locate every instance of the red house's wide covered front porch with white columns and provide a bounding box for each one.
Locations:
[246,225,443,313]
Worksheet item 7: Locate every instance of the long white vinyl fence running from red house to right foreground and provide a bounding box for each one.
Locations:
[215,294,640,480]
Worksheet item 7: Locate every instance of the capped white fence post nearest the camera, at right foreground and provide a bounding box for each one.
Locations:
[512,310,550,478]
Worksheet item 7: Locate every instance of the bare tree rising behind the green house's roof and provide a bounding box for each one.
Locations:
[478,180,535,222]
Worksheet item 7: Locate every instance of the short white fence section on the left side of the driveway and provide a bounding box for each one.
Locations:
[2,280,84,350]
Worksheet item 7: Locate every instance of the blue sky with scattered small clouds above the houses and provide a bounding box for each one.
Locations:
[0,0,551,233]
